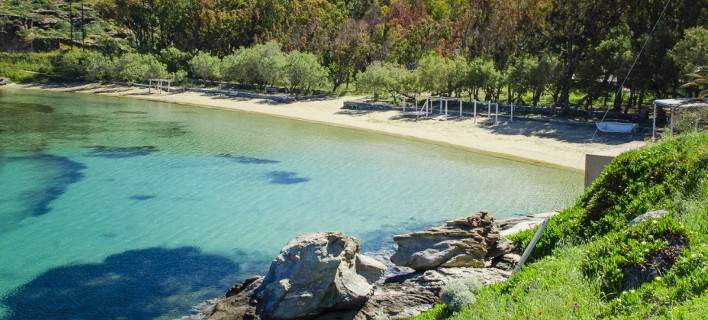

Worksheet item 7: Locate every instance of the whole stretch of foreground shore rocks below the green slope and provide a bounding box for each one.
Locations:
[185,212,555,320]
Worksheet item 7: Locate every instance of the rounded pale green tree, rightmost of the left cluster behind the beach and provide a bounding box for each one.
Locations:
[283,50,327,92]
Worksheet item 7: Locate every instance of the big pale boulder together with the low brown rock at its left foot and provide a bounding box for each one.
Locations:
[202,232,378,320]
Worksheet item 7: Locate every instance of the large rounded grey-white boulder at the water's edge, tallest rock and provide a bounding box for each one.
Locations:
[255,232,373,319]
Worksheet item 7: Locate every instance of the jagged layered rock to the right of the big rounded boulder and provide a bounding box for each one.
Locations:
[391,212,514,270]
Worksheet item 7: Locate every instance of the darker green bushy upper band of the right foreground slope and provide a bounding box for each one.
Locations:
[514,134,708,257]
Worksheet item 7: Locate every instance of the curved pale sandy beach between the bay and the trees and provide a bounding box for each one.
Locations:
[10,84,643,171]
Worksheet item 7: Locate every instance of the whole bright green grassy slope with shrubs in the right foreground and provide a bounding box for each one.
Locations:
[418,133,708,319]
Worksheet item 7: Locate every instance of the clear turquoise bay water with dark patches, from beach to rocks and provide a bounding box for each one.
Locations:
[0,90,582,319]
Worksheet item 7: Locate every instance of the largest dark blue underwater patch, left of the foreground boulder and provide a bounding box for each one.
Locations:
[0,247,240,320]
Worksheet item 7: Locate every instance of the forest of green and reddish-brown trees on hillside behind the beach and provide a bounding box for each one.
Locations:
[3,0,708,109]
